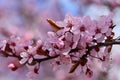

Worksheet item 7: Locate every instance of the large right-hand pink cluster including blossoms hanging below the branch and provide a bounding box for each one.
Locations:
[43,14,114,75]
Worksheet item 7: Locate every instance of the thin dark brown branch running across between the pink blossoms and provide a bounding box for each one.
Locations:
[0,40,120,73]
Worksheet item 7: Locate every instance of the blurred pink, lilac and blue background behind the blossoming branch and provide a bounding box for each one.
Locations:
[0,0,120,80]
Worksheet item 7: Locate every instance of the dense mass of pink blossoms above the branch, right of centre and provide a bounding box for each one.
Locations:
[45,14,112,55]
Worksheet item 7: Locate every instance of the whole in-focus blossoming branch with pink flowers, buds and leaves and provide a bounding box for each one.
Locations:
[0,14,119,76]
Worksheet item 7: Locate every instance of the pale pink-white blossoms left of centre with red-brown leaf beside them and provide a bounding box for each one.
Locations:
[19,40,45,64]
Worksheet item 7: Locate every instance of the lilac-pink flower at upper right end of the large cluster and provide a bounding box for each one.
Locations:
[94,15,112,40]
